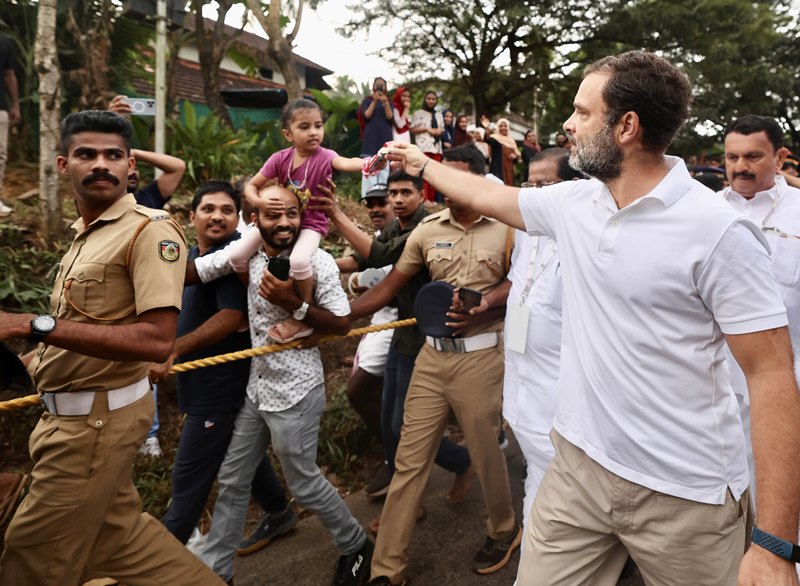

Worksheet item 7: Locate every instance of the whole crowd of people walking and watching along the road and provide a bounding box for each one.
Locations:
[0,52,800,586]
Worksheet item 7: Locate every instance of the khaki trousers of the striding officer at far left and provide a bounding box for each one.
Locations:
[0,386,223,586]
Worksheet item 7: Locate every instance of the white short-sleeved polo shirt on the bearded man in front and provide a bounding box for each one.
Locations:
[519,157,787,504]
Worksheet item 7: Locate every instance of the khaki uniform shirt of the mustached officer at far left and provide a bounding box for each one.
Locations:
[29,194,186,393]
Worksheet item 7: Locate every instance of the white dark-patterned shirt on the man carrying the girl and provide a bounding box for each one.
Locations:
[247,249,350,412]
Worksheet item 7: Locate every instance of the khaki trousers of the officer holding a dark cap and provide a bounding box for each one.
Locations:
[372,344,516,584]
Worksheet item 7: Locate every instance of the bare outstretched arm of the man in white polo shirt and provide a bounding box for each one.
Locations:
[389,142,525,230]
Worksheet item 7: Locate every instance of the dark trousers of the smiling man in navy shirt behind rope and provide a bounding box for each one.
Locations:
[161,412,287,544]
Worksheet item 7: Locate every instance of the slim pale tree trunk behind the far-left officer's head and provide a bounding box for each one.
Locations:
[36,0,63,242]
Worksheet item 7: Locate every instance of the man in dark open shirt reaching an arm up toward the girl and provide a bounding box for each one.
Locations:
[317,171,472,502]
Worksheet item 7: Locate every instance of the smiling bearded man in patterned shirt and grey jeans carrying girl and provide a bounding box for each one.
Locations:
[202,186,372,586]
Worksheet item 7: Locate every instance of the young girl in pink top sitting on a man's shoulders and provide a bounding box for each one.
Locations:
[230,99,382,343]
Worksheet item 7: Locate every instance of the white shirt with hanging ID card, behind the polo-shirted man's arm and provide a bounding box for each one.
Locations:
[503,230,562,434]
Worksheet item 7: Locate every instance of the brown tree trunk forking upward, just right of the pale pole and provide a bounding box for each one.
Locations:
[192,0,248,127]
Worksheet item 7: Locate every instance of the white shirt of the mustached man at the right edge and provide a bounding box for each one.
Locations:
[719,175,800,384]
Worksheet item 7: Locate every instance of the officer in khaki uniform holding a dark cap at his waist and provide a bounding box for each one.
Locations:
[352,145,521,585]
